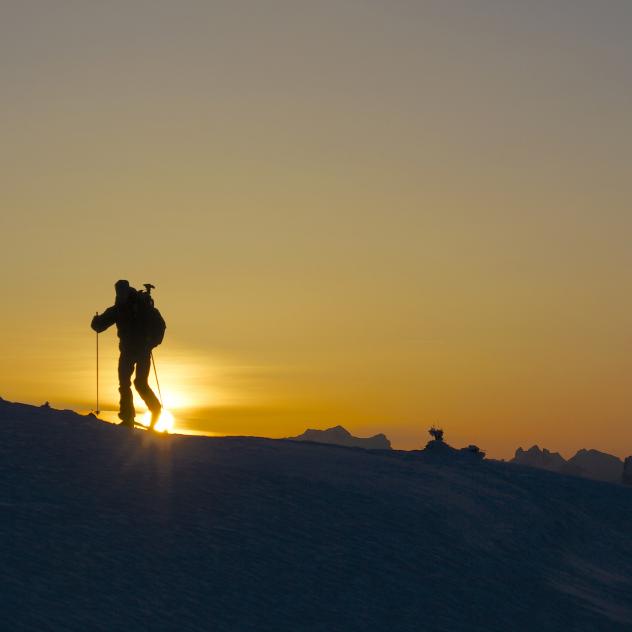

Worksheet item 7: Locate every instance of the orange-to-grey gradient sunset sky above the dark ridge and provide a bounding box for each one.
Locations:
[0,0,632,457]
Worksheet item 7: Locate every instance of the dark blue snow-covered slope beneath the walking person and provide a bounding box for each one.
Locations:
[0,402,632,632]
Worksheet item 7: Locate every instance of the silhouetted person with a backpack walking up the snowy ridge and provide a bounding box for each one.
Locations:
[91,279,166,428]
